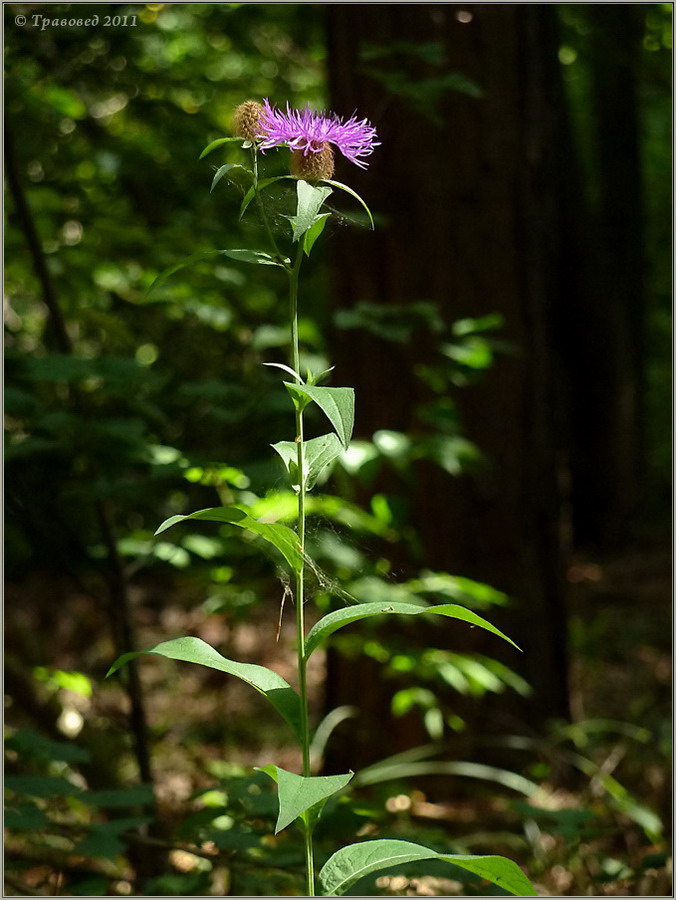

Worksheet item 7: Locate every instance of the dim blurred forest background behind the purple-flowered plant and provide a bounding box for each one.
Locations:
[4,3,672,896]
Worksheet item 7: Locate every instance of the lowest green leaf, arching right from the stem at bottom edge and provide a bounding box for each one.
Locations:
[319,840,537,897]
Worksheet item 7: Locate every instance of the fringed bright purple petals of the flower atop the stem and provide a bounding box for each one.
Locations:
[258,99,380,169]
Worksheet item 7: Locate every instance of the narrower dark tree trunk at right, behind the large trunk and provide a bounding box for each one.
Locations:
[569,4,645,548]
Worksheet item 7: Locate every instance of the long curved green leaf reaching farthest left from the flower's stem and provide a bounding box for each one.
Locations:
[106,637,301,737]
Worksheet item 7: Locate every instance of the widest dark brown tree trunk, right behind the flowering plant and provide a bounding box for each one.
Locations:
[327,4,575,765]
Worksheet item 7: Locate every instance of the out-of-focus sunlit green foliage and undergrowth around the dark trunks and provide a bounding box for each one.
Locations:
[4,4,671,896]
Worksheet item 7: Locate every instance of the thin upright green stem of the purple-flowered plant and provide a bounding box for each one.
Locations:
[288,235,315,897]
